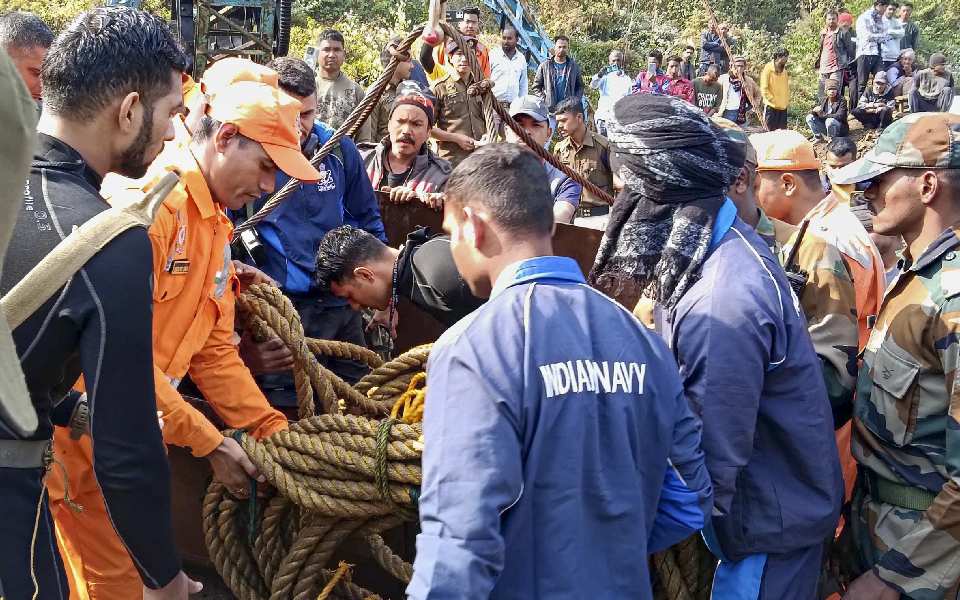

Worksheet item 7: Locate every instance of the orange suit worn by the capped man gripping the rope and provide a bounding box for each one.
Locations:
[48,120,287,600]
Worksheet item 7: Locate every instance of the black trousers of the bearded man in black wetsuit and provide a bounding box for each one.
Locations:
[0,468,70,600]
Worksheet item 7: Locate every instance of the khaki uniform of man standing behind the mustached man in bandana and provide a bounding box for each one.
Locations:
[433,73,487,167]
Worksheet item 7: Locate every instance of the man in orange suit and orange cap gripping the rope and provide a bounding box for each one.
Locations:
[49,69,319,599]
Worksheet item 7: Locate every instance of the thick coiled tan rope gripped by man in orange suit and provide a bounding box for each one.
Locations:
[203,285,429,600]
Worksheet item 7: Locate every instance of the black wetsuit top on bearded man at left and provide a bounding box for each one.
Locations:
[0,134,180,588]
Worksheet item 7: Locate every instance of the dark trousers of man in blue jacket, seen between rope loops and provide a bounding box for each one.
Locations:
[257,297,370,406]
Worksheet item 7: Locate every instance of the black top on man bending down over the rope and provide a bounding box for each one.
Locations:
[397,228,484,327]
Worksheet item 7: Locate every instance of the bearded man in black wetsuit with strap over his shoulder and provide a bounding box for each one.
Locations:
[0,8,200,600]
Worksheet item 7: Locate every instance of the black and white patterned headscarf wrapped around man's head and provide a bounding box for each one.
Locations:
[590,94,744,308]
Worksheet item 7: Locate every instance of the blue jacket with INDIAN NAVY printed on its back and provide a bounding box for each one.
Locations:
[407,256,712,600]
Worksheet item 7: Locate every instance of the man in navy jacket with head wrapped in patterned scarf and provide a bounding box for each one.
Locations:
[592,94,843,600]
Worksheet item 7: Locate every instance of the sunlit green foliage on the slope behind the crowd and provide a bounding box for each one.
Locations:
[0,0,960,125]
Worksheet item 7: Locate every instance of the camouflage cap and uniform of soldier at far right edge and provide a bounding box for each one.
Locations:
[834,113,960,600]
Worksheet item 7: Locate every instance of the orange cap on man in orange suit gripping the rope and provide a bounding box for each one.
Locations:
[207,81,320,181]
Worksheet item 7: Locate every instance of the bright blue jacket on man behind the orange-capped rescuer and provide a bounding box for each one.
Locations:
[230,122,387,298]
